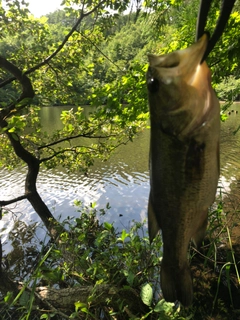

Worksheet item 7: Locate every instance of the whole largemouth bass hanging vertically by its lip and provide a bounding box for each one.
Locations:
[147,34,220,306]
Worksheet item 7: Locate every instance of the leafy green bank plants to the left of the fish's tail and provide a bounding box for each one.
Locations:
[1,201,183,320]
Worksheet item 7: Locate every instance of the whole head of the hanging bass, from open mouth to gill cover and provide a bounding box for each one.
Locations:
[146,34,215,139]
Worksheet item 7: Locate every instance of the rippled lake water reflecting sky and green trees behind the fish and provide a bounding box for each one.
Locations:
[0,105,240,254]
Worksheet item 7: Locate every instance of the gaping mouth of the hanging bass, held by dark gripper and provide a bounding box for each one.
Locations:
[148,34,208,84]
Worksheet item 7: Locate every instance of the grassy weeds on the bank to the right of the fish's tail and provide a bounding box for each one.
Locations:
[187,189,240,320]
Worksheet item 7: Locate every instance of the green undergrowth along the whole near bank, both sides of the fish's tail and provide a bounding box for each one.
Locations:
[0,199,240,320]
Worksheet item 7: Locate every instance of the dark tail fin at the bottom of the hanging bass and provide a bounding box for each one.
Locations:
[160,260,193,307]
